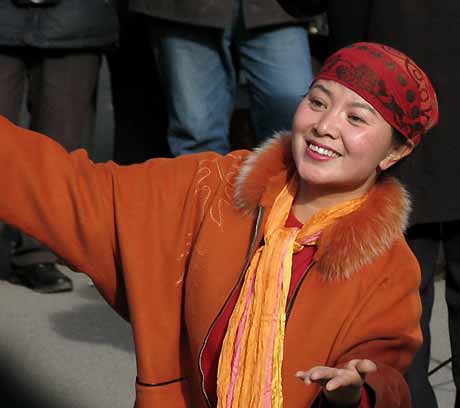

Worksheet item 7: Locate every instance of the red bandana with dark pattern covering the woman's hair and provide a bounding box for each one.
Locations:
[315,42,439,143]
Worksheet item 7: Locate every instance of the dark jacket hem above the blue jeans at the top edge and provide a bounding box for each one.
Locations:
[130,0,305,29]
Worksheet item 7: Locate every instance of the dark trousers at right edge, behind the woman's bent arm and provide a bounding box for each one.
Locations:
[406,221,460,408]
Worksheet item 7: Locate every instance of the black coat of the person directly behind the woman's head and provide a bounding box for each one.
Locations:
[281,0,460,224]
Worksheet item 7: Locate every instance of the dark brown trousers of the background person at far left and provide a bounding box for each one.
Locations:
[0,47,101,266]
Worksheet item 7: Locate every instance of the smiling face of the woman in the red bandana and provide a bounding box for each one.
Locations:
[292,80,411,198]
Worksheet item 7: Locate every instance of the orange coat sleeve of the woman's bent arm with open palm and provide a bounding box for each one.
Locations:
[328,238,422,408]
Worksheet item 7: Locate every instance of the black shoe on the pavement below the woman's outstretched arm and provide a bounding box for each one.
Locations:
[8,263,73,293]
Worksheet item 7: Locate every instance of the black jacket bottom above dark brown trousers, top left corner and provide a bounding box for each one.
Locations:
[0,0,118,49]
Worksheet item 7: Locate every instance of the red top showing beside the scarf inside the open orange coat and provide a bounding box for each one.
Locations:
[201,212,316,406]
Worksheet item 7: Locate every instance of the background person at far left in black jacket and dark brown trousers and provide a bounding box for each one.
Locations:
[0,0,118,293]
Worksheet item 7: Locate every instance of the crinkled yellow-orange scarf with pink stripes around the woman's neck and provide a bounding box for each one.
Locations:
[217,177,365,408]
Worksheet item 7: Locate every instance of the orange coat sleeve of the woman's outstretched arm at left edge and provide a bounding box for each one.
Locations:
[0,117,126,316]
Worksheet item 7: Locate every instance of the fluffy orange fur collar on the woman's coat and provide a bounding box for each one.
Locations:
[234,132,411,280]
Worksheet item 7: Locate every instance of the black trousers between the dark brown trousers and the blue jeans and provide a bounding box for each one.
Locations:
[106,9,171,164]
